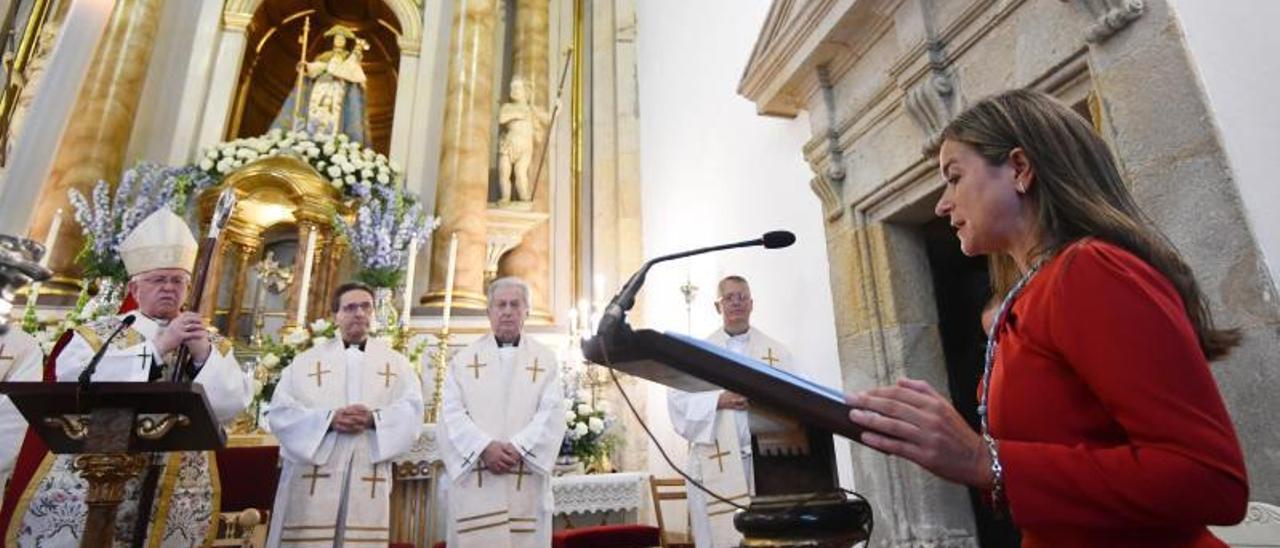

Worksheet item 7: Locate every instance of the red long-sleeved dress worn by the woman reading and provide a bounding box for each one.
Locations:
[991,239,1248,547]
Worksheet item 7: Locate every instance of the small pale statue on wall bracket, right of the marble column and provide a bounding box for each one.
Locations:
[498,77,548,209]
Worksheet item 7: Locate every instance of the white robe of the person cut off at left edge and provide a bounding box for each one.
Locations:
[0,326,45,497]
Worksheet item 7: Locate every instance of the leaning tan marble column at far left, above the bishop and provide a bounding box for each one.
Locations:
[31,0,163,277]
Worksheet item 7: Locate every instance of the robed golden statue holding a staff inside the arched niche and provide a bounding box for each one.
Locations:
[271,24,371,146]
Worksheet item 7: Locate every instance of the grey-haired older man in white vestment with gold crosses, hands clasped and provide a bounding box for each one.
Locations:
[438,278,566,548]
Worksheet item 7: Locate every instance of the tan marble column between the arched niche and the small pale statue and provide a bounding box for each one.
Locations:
[426,0,498,309]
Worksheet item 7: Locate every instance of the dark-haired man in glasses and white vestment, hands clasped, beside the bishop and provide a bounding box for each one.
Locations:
[266,282,422,547]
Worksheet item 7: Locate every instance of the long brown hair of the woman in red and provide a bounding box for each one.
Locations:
[942,90,1240,361]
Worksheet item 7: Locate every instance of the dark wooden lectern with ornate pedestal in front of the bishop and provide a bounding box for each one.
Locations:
[0,383,227,548]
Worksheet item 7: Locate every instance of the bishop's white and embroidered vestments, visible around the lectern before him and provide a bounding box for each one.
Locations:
[4,311,252,547]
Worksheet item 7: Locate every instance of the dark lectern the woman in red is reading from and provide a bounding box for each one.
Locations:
[582,328,872,547]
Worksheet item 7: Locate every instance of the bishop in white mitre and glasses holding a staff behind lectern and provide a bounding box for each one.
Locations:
[0,209,251,547]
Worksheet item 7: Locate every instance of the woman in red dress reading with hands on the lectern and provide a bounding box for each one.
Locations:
[849,90,1248,547]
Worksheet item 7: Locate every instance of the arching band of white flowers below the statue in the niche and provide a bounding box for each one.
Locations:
[197,128,403,198]
